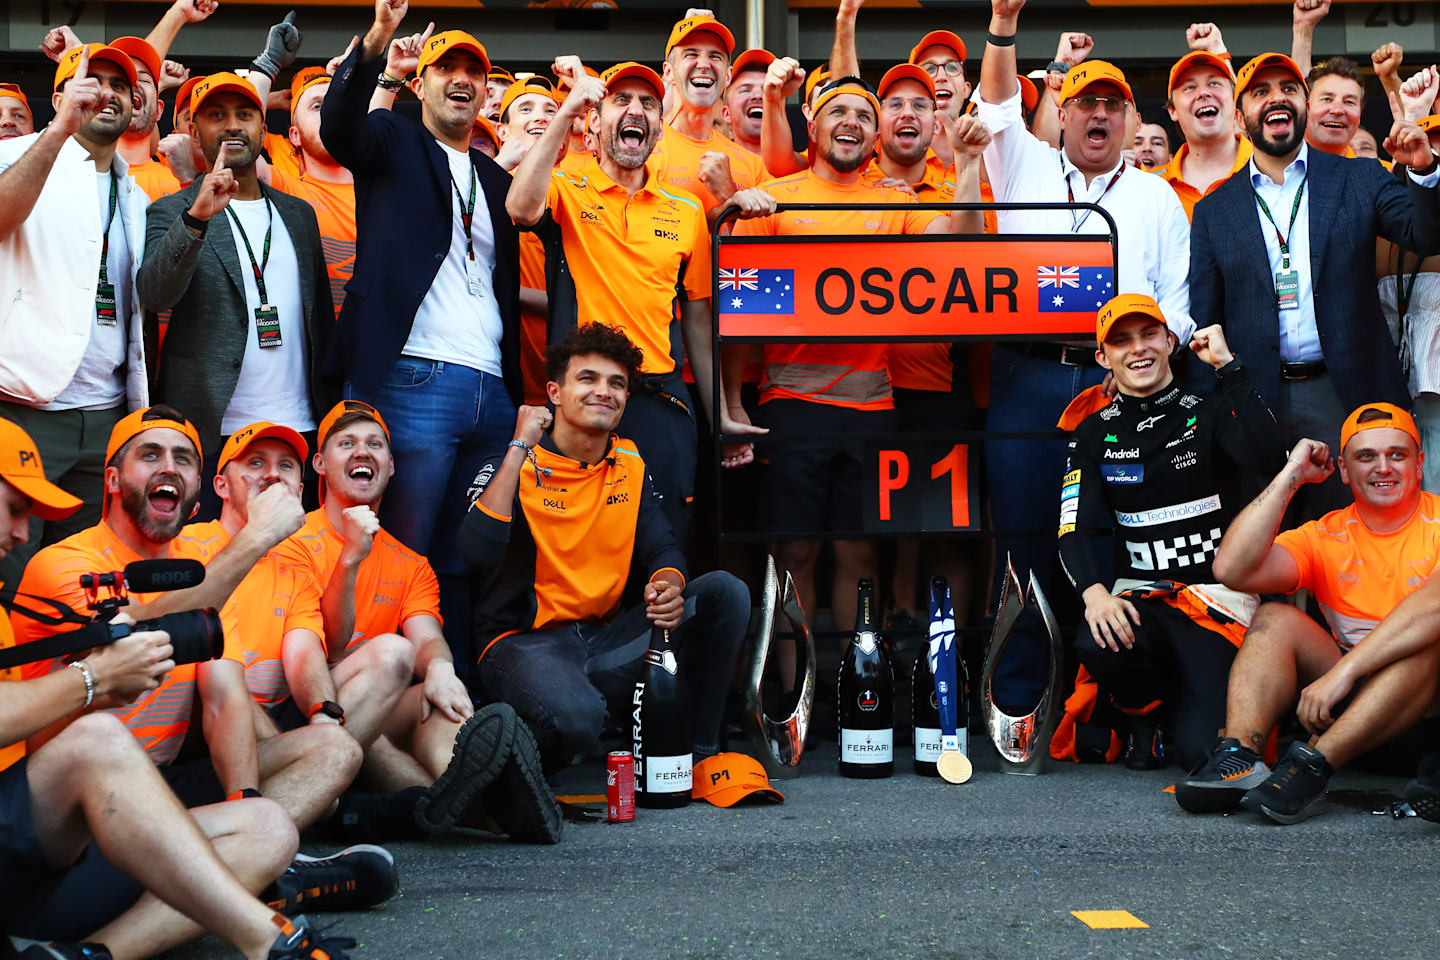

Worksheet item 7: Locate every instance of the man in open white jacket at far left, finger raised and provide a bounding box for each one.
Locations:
[0,43,148,563]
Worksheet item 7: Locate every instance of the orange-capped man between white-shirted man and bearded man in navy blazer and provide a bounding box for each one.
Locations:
[1156,45,1253,219]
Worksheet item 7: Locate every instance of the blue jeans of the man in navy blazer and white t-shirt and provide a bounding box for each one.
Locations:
[346,356,516,679]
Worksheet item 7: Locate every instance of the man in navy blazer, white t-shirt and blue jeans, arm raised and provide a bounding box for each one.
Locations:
[320,0,520,678]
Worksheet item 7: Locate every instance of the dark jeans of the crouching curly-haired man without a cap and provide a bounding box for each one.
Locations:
[480,570,750,770]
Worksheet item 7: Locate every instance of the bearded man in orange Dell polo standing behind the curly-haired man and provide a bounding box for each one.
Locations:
[505,56,771,538]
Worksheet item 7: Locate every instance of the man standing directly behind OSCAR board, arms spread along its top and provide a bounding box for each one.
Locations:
[724,76,989,639]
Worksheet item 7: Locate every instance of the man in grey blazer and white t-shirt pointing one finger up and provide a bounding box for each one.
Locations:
[137,73,334,518]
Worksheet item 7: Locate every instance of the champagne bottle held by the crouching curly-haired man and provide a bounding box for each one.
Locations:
[631,626,694,807]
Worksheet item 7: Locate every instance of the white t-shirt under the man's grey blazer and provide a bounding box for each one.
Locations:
[220,197,315,436]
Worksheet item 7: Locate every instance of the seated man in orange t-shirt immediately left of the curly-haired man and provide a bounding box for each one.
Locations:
[275,400,562,843]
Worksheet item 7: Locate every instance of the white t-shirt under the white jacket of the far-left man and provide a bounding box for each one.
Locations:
[40,171,134,410]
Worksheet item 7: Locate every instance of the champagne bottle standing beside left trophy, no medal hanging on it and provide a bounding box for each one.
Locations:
[835,580,894,777]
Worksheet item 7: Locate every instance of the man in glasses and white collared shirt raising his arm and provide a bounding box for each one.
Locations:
[976,0,1195,712]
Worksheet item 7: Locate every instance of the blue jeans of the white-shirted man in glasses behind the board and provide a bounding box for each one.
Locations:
[985,344,1115,712]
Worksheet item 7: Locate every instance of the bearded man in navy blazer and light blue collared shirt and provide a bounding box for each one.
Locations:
[1189,53,1440,514]
